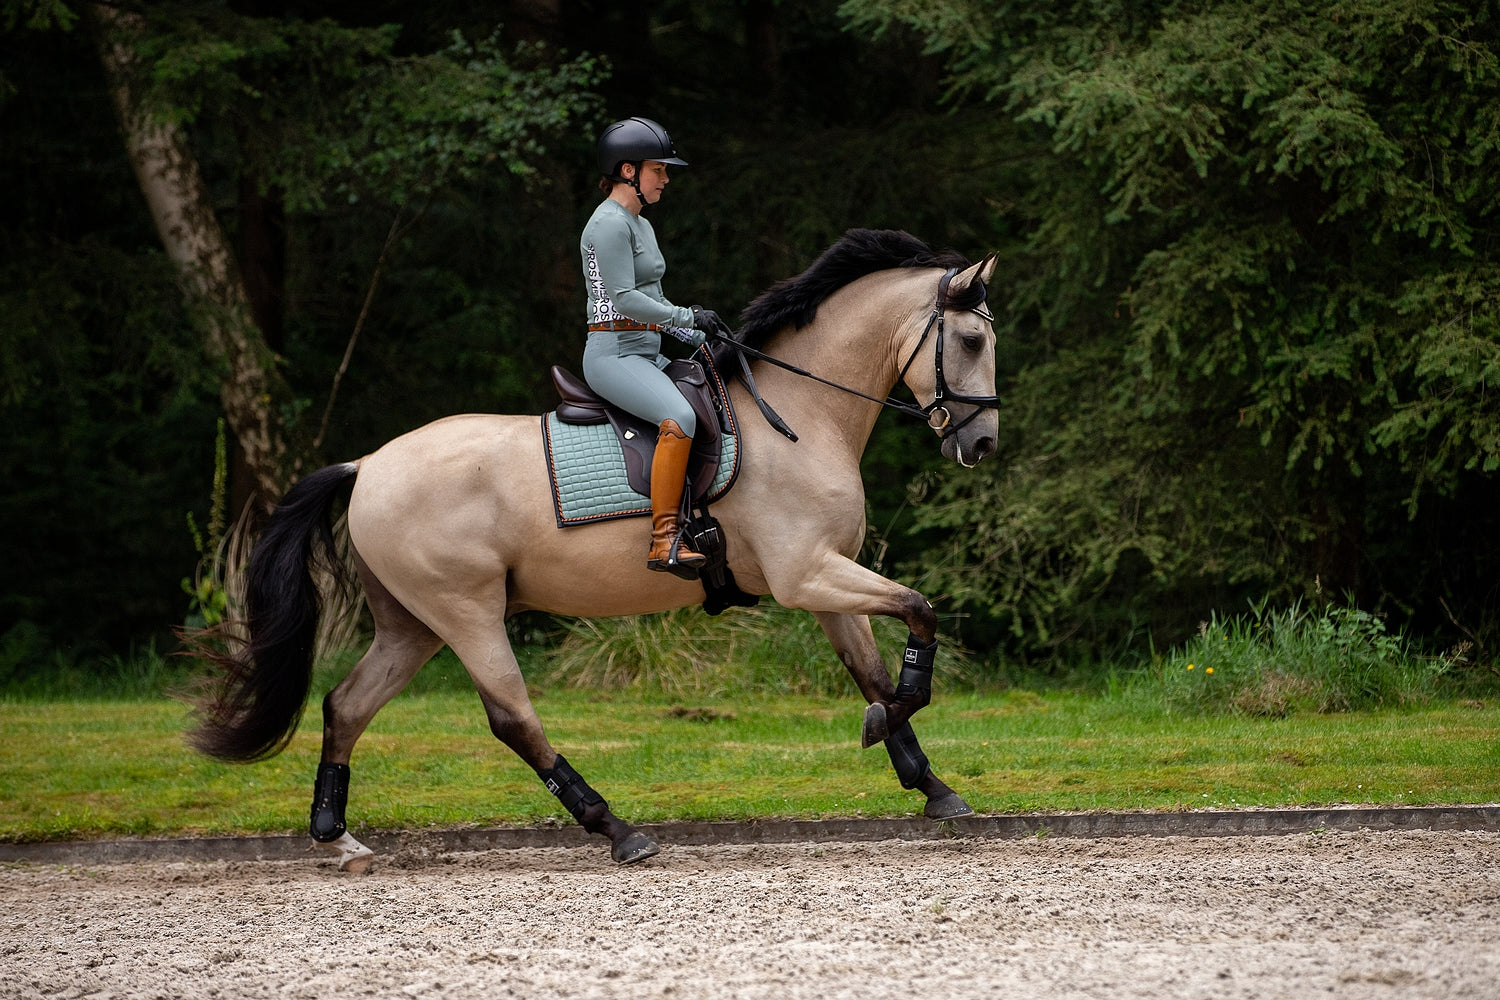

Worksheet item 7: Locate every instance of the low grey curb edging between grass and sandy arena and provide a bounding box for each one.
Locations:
[0,804,1500,865]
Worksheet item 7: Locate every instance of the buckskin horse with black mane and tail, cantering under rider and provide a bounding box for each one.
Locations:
[189,229,999,873]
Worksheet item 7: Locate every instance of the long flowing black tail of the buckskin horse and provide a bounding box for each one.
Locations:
[188,463,359,762]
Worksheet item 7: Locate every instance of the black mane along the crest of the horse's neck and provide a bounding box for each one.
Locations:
[735,229,984,348]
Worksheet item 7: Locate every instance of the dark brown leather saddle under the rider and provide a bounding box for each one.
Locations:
[552,358,737,502]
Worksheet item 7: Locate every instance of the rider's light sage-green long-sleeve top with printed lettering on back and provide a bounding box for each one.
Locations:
[579,198,693,342]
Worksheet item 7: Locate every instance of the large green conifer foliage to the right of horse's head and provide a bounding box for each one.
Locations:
[842,0,1500,654]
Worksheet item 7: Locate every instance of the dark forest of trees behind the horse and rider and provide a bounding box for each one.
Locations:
[0,0,1500,669]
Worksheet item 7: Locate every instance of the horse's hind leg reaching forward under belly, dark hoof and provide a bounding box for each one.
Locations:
[449,615,662,865]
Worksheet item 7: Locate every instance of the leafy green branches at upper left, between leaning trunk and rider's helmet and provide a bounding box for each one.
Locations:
[118,11,602,211]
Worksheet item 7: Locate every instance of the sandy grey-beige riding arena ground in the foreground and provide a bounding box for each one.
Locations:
[0,832,1500,1000]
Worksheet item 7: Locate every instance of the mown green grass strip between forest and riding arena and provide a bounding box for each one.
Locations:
[0,690,1500,841]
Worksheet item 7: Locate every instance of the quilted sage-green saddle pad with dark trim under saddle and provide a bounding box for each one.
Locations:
[542,412,740,528]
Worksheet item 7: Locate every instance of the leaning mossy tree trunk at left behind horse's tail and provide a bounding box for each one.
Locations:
[93,4,302,501]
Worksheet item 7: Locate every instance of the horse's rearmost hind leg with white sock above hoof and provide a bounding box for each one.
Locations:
[309,556,443,873]
